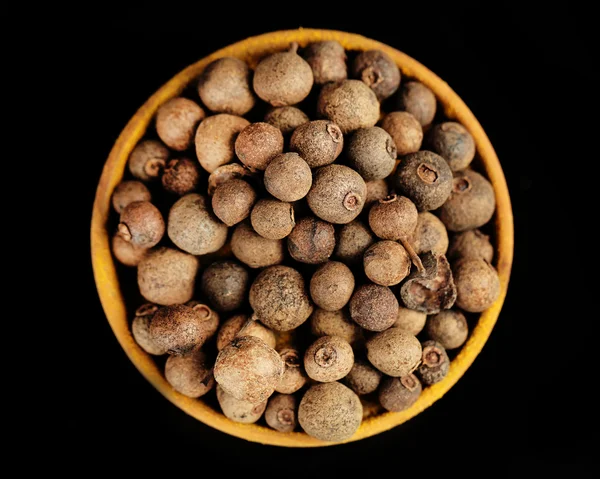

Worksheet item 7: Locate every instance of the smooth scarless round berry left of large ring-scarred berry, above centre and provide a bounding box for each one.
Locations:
[264,153,312,202]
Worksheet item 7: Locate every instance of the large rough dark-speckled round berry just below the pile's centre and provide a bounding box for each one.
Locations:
[249,266,313,331]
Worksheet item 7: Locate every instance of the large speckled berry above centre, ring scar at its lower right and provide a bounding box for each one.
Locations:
[306,165,367,224]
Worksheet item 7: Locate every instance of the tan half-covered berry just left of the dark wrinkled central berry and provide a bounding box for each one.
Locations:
[231,223,285,268]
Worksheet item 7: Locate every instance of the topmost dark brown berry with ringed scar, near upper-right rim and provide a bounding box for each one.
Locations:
[352,50,400,101]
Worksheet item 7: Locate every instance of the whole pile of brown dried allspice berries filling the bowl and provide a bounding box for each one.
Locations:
[111,41,500,441]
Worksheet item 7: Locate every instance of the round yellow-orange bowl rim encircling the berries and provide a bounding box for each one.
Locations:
[91,29,513,447]
